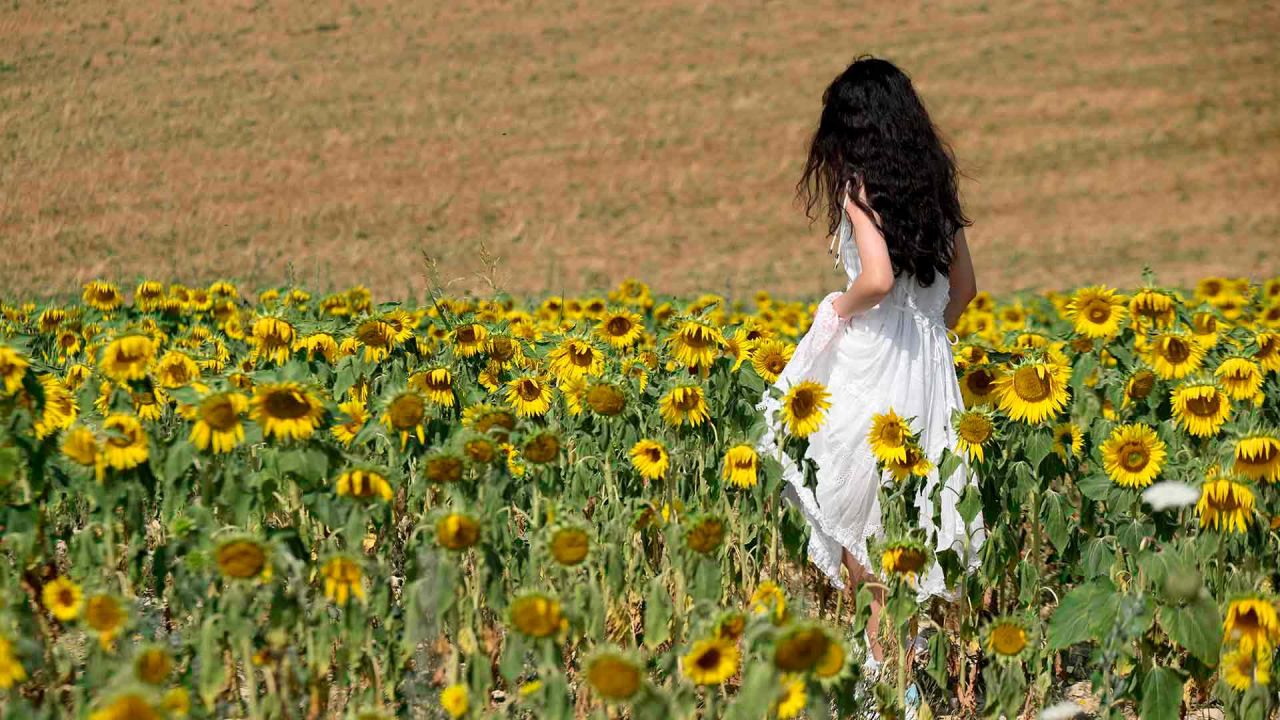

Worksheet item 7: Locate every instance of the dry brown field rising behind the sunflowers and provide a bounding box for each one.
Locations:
[0,0,1280,299]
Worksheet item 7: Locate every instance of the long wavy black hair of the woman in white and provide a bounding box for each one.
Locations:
[796,55,973,287]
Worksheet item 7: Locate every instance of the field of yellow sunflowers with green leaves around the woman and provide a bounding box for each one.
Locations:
[0,270,1280,720]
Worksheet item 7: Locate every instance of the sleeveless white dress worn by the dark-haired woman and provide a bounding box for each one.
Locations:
[756,202,986,600]
